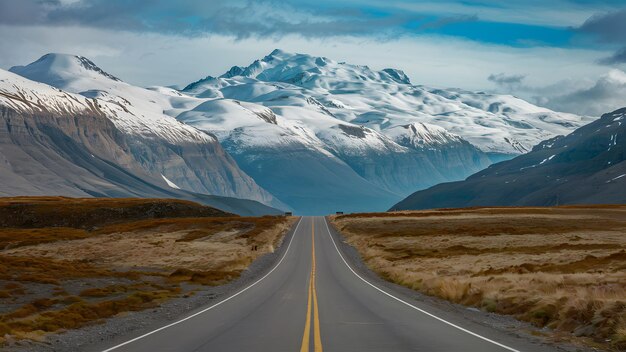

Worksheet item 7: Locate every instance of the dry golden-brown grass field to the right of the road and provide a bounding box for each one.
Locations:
[332,206,626,350]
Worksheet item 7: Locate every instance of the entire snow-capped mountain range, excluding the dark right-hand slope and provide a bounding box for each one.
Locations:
[0,49,593,215]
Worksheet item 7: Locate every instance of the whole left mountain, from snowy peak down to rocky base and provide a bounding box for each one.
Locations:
[0,54,286,212]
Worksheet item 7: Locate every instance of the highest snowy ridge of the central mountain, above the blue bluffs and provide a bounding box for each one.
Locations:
[182,49,591,154]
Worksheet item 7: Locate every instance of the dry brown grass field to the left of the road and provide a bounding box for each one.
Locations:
[0,197,295,346]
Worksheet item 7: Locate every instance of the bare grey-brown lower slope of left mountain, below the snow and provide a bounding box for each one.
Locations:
[0,106,280,215]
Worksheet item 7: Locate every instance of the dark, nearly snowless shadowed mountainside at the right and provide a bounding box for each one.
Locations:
[391,108,626,210]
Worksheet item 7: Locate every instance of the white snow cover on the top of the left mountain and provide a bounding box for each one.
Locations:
[5,54,216,143]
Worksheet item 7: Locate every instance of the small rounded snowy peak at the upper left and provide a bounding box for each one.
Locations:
[9,53,121,86]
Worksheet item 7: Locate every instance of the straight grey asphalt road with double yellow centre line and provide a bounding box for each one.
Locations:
[100,217,552,352]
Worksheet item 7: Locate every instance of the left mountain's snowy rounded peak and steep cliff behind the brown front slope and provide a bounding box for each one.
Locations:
[7,54,284,207]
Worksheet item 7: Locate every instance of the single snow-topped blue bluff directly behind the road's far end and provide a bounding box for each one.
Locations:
[178,99,398,214]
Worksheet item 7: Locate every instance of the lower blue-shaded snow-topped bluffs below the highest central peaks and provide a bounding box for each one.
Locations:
[178,83,489,213]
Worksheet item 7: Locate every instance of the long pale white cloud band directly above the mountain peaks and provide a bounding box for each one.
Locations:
[0,26,626,115]
